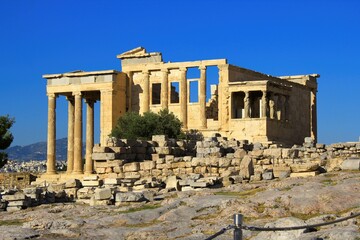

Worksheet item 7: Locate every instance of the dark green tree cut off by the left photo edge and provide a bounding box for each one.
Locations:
[0,115,15,168]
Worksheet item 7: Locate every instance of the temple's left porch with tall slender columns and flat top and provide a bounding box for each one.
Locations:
[43,70,126,174]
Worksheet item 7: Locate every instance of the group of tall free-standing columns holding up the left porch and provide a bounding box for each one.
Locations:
[47,92,95,174]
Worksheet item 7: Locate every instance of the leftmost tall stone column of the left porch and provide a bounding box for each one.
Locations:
[46,93,56,174]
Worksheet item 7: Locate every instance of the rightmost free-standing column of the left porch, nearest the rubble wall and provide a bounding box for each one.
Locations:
[85,99,95,174]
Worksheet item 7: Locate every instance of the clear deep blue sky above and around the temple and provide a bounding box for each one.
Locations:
[0,0,360,146]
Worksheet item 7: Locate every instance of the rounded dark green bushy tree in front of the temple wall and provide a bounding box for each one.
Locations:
[111,109,183,140]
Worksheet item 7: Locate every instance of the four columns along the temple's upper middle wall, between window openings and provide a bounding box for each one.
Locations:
[142,66,207,129]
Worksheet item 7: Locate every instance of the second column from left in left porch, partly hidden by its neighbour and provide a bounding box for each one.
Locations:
[66,97,74,173]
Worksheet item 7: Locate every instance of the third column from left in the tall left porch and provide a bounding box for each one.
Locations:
[73,92,83,174]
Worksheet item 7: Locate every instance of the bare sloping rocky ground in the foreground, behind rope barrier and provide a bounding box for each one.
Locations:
[0,171,360,240]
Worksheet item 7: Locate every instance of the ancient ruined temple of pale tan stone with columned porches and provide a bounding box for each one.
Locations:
[43,47,319,174]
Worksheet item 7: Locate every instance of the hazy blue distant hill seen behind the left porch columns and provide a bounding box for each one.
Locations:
[6,138,85,161]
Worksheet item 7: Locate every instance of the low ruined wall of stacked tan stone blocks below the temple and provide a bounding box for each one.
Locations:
[93,135,360,180]
